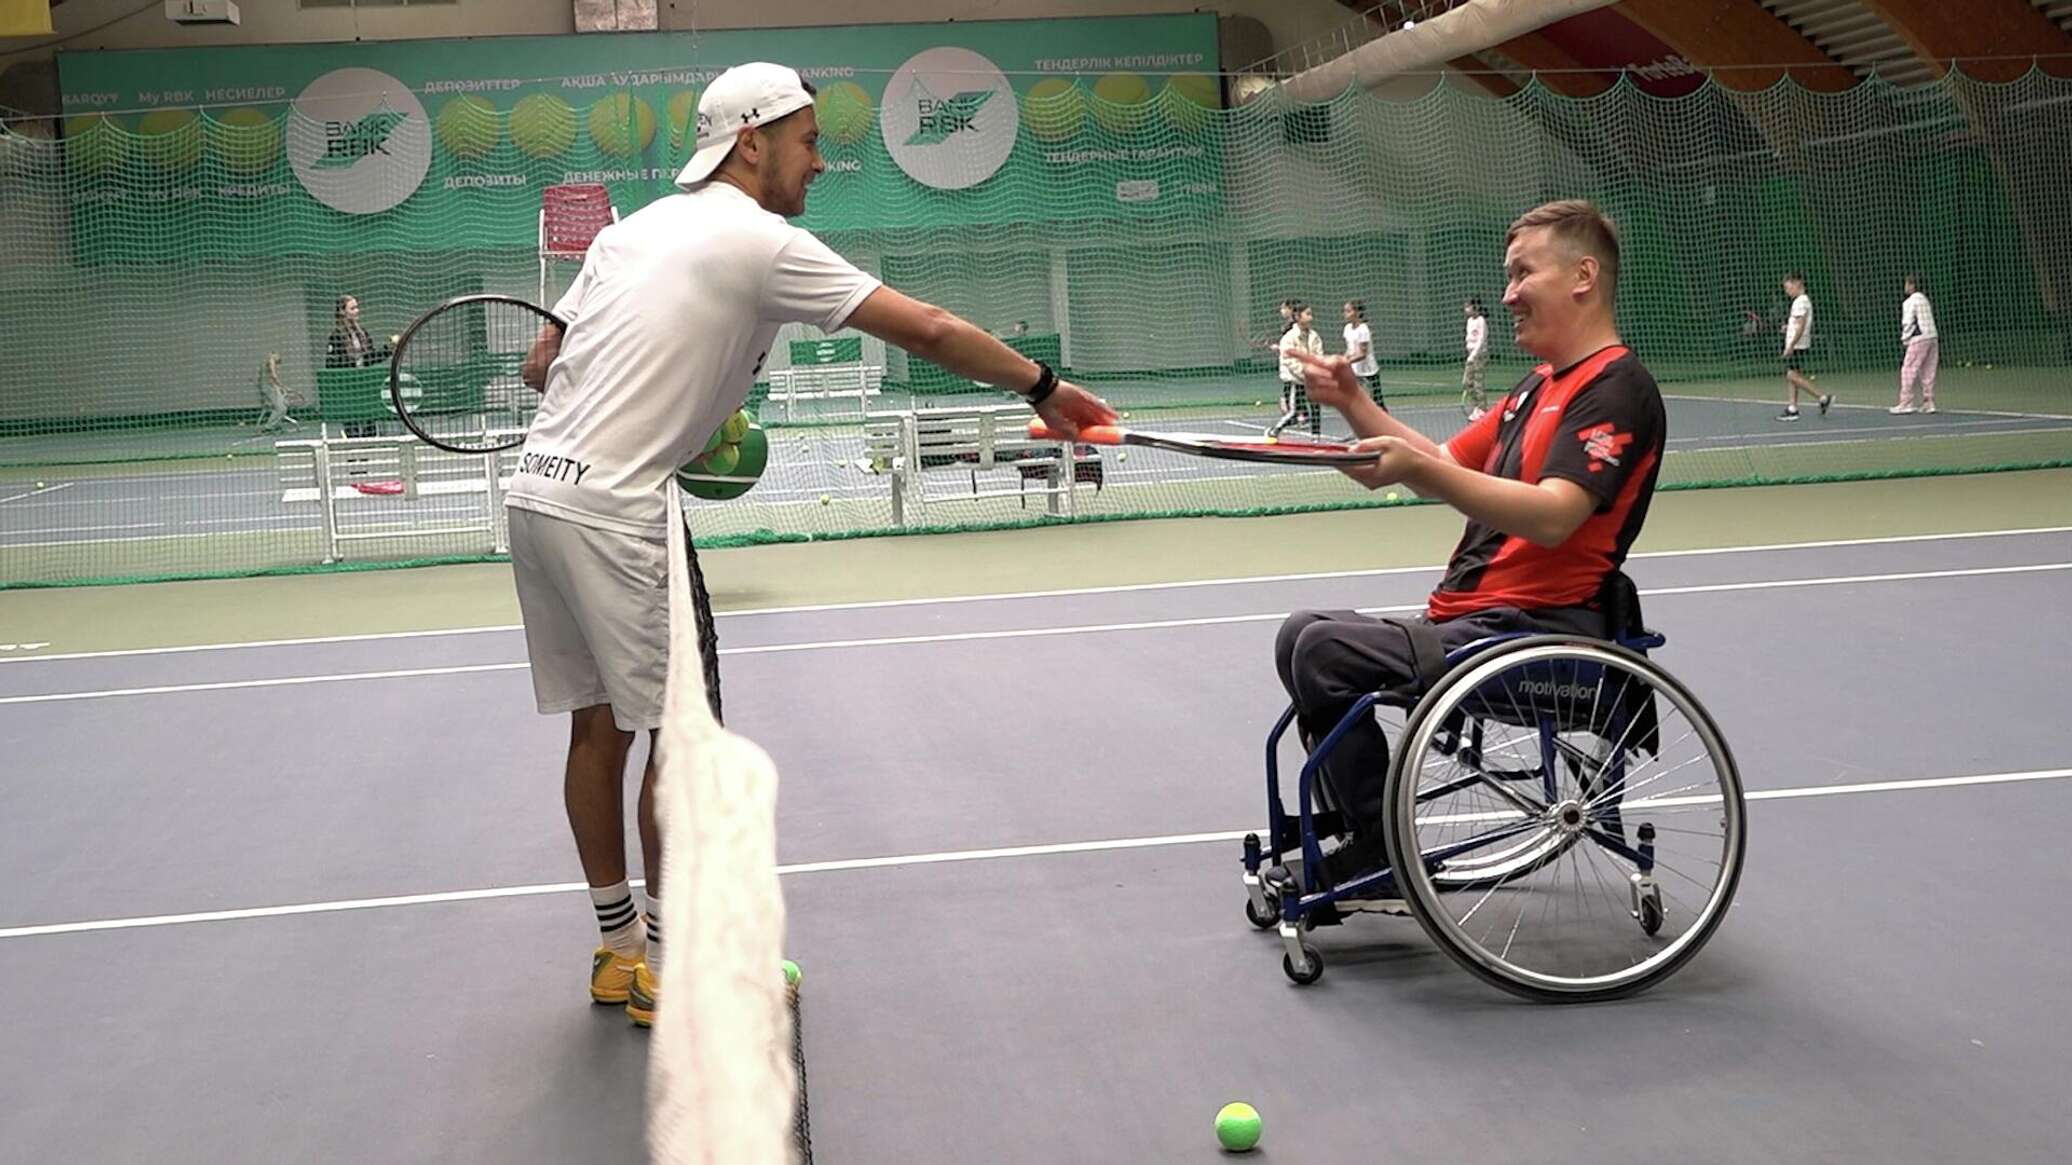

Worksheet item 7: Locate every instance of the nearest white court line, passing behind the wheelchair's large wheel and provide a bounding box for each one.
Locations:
[0,769,2072,939]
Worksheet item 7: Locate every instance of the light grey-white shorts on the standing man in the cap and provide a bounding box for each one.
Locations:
[506,506,669,732]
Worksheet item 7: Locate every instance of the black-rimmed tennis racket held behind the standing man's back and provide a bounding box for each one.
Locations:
[390,294,566,454]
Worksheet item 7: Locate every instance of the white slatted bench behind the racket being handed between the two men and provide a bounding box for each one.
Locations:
[864,404,1102,527]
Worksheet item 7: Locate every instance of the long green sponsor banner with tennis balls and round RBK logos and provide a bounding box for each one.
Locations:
[58,15,1220,259]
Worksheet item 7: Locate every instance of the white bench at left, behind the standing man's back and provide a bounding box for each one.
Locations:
[274,435,520,564]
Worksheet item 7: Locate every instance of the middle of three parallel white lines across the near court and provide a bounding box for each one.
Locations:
[0,562,2072,705]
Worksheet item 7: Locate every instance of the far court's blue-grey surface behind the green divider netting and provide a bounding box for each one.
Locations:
[0,394,2072,549]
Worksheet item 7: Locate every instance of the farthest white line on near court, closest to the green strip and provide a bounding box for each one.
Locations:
[0,527,2072,663]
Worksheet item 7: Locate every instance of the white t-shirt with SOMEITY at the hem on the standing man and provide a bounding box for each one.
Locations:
[506,182,881,539]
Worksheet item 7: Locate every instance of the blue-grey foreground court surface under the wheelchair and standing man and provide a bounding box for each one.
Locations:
[0,531,2072,1165]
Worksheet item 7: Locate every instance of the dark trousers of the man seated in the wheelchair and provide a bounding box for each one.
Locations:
[1274,607,1606,837]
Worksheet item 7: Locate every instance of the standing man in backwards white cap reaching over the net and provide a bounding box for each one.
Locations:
[508,62,1115,1024]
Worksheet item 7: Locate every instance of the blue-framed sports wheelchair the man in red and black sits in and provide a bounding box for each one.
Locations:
[1243,574,1747,1003]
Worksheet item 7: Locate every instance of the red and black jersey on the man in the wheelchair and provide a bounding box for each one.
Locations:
[1428,344,1668,622]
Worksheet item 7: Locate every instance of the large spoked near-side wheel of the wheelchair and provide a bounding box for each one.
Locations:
[1384,636,1747,1001]
